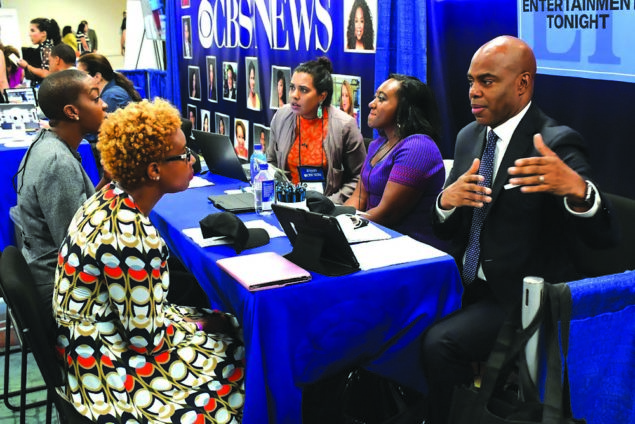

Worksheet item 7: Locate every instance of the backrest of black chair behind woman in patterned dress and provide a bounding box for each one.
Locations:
[0,246,64,390]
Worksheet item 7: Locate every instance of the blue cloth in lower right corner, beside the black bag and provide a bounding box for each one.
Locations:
[568,271,635,424]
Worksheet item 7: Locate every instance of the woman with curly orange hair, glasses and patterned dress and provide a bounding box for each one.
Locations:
[53,99,245,423]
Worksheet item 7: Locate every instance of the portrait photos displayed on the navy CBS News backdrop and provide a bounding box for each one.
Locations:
[180,0,377,160]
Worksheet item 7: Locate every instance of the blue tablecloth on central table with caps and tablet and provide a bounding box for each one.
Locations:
[151,176,462,424]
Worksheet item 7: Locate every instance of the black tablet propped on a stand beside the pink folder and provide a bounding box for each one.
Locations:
[271,204,359,276]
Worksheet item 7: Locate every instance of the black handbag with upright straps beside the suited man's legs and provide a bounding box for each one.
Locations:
[449,283,586,424]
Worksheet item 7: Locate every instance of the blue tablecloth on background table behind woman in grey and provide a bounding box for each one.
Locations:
[0,142,99,250]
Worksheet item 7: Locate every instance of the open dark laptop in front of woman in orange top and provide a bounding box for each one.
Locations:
[192,130,249,182]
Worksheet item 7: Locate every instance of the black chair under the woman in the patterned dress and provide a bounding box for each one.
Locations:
[0,246,92,424]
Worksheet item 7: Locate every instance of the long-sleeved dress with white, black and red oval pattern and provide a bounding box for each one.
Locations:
[53,184,245,423]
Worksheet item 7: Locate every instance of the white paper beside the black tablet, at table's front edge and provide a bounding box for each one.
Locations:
[351,236,447,270]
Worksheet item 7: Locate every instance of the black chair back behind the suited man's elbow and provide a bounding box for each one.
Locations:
[574,193,635,277]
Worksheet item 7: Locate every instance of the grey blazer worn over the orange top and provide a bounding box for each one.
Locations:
[267,104,366,204]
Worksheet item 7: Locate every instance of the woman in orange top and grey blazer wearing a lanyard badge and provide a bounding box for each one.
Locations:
[267,57,366,204]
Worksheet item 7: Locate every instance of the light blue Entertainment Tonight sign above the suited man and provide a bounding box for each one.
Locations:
[518,0,635,82]
